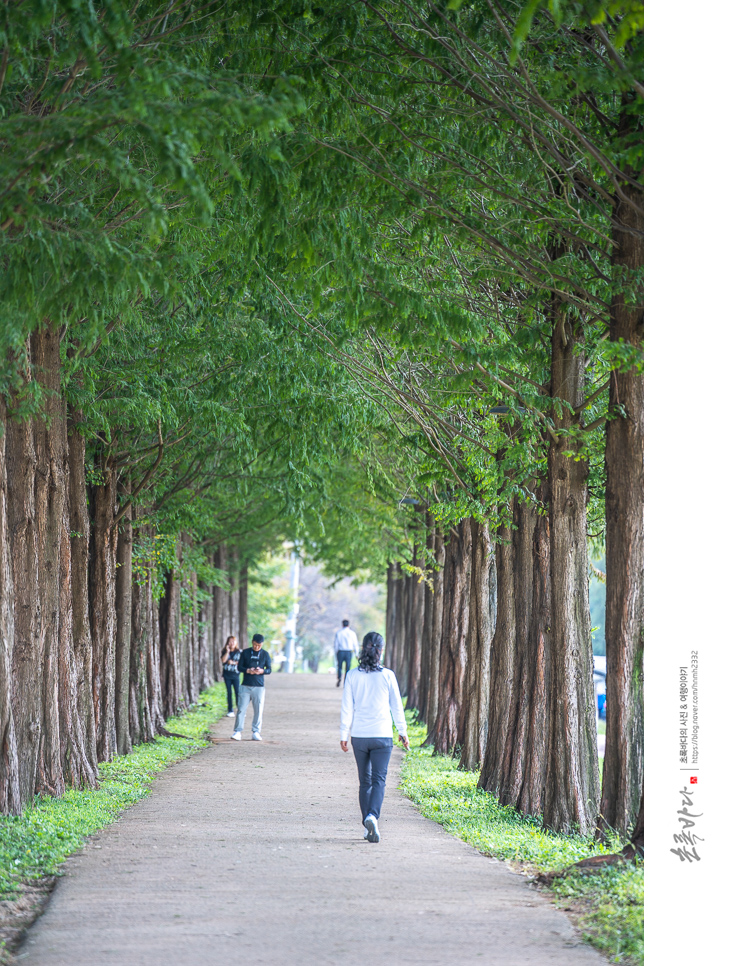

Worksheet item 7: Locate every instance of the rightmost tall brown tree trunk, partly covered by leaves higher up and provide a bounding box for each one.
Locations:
[599,163,644,833]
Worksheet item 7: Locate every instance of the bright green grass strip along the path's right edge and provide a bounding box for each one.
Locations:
[401,715,644,966]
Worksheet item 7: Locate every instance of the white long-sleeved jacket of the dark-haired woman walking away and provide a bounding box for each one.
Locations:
[340,667,407,741]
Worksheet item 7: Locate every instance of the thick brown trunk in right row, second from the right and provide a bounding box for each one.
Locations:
[543,306,600,834]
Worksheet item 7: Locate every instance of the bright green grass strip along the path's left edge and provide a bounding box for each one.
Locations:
[0,683,226,899]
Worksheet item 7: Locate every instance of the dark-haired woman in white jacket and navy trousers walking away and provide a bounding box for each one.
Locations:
[340,631,410,842]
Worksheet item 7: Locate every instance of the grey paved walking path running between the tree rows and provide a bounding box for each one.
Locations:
[18,674,605,966]
